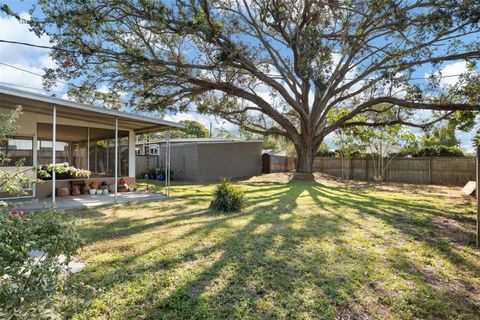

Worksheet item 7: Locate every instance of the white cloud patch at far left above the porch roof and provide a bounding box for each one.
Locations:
[0,13,64,92]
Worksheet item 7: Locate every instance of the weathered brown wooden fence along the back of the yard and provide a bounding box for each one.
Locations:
[264,156,475,185]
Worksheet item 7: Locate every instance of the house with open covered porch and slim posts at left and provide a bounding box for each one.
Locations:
[0,86,182,202]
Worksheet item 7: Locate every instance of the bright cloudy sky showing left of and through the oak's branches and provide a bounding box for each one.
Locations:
[0,0,473,152]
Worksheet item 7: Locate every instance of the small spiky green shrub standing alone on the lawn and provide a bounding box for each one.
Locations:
[211,178,247,212]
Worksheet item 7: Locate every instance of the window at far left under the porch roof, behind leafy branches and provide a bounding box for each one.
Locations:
[0,136,33,167]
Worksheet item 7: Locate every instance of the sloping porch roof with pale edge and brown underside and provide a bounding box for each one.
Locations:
[0,86,183,133]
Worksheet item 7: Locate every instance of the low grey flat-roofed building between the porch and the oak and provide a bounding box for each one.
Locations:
[135,138,262,182]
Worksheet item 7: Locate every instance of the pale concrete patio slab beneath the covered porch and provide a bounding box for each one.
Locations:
[16,191,166,211]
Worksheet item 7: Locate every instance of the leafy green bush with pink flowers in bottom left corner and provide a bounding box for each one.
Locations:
[0,210,82,319]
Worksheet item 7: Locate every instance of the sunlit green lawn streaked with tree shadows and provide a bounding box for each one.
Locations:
[62,175,480,319]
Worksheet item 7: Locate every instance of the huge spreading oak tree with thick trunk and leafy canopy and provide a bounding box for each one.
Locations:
[6,0,480,173]
